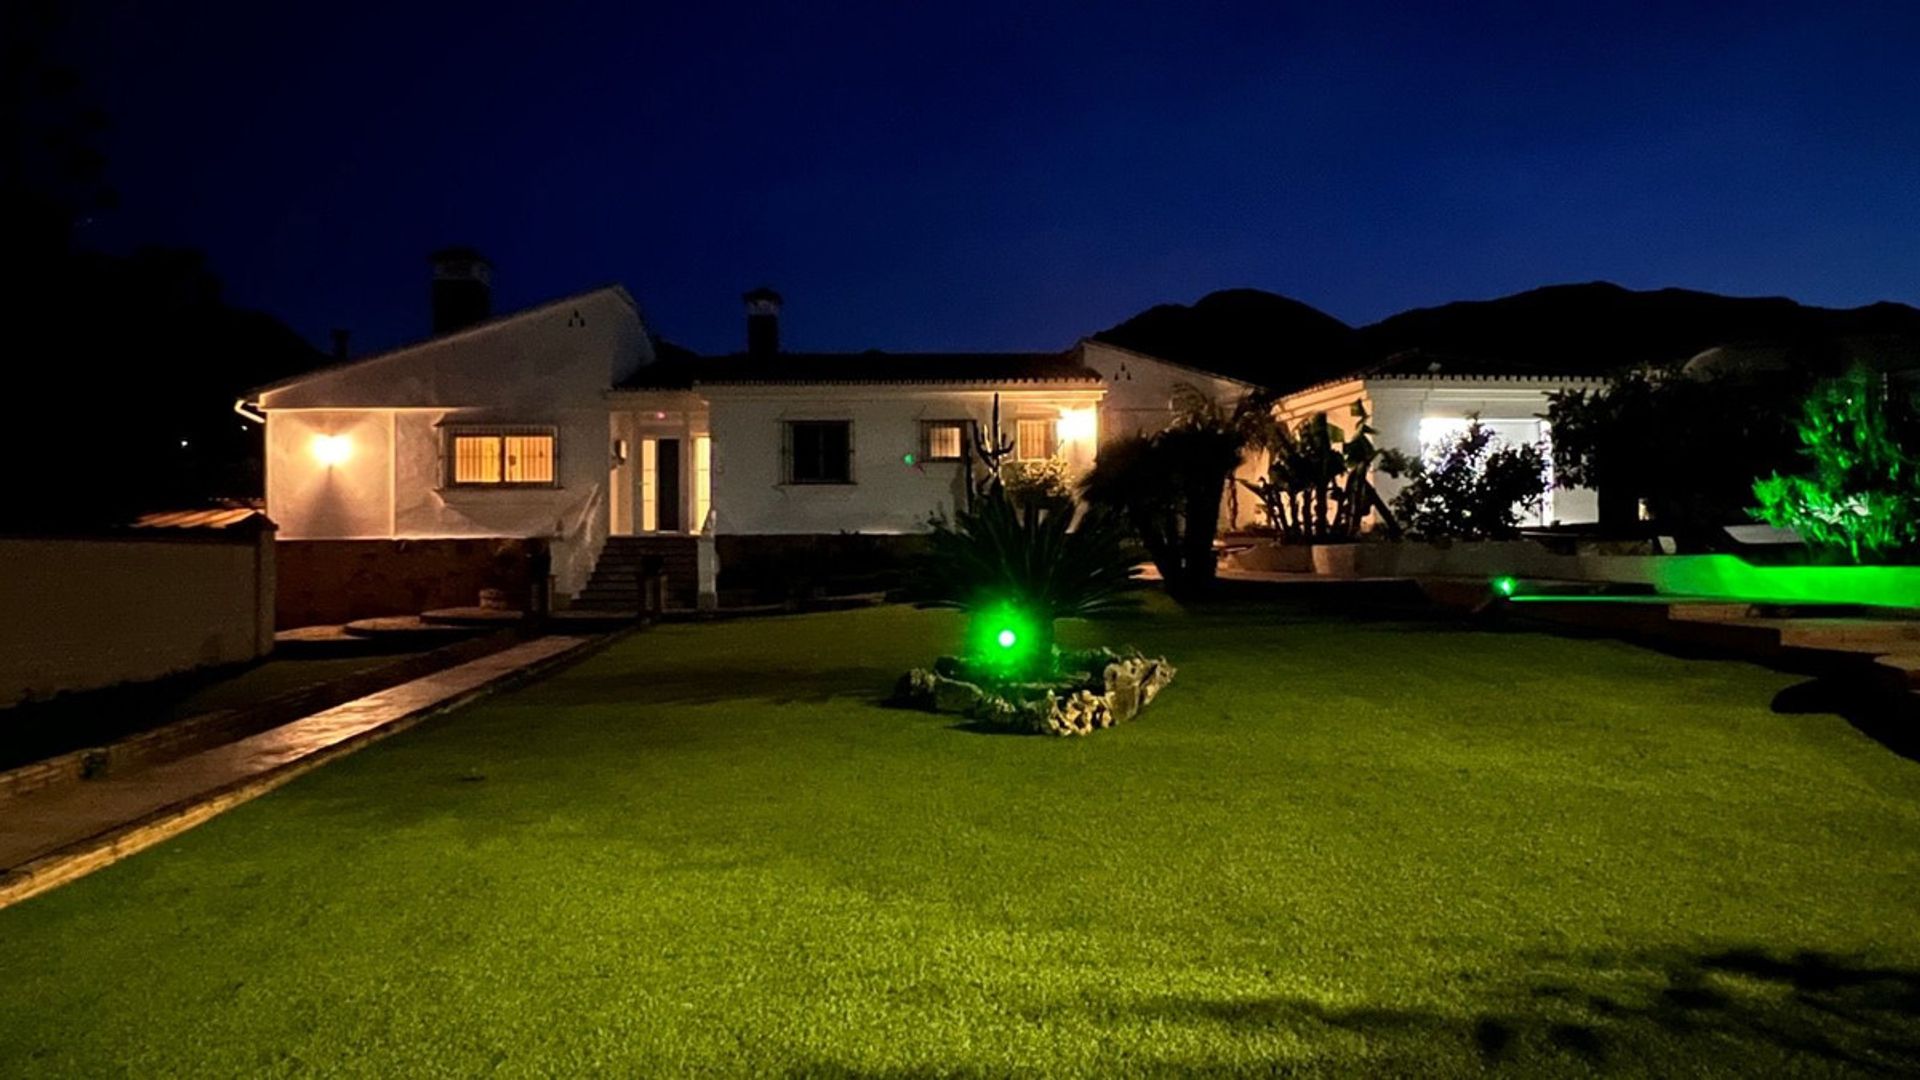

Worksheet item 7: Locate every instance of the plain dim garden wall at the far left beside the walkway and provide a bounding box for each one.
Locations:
[0,527,276,705]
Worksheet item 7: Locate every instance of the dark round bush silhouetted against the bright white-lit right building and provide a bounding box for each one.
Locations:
[1386,417,1548,540]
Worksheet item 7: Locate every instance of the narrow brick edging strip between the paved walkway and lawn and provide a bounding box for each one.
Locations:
[0,628,634,909]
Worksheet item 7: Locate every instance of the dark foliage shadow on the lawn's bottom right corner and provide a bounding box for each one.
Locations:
[1139,947,1920,1074]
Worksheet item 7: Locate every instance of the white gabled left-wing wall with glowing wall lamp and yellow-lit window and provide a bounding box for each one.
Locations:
[259,288,653,592]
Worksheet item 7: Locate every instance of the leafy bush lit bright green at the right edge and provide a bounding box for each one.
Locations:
[1753,369,1920,563]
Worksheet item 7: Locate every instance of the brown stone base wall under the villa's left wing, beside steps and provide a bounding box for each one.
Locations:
[275,538,547,630]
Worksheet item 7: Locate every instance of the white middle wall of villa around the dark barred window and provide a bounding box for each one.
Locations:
[703,384,1100,534]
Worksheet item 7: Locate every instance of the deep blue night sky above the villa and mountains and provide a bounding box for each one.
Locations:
[63,0,1920,350]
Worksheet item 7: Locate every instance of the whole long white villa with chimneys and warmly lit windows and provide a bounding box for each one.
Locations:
[236,250,1592,603]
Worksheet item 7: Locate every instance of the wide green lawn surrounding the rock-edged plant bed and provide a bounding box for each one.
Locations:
[0,609,1920,1076]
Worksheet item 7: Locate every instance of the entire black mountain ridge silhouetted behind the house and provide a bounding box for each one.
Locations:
[1094,282,1920,390]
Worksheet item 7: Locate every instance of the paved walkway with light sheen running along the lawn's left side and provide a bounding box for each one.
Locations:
[0,636,593,907]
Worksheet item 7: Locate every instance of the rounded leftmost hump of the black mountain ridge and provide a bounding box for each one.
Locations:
[1092,288,1361,386]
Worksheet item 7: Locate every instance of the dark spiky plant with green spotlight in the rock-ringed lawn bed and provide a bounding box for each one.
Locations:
[920,488,1135,676]
